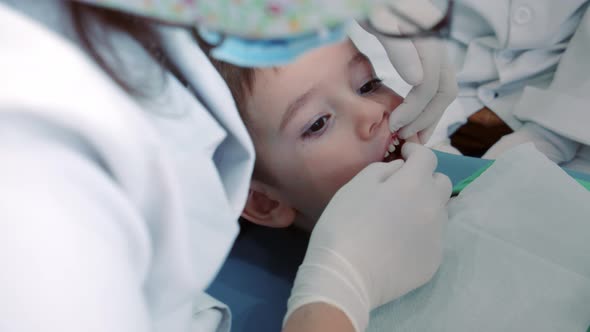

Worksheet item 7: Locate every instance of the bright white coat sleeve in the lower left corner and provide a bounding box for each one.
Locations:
[0,122,151,332]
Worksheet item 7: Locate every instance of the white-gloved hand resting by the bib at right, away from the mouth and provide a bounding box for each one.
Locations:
[482,122,579,164]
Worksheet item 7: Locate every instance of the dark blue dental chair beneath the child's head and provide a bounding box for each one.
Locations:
[208,152,590,332]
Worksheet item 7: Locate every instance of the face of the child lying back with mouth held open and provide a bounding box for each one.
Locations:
[244,41,403,227]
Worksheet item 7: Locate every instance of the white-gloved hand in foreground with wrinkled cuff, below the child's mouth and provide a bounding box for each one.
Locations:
[285,143,451,331]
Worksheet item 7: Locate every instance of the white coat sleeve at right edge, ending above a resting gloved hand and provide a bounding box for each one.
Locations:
[514,7,590,161]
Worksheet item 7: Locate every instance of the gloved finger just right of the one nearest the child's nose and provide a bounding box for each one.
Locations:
[399,52,459,143]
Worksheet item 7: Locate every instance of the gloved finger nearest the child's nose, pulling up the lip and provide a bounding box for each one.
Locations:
[389,39,441,134]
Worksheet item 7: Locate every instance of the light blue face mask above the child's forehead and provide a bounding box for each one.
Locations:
[199,24,346,67]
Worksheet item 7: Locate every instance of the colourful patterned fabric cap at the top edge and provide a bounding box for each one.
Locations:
[79,0,383,39]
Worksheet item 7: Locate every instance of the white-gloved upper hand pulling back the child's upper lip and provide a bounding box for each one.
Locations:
[369,0,458,143]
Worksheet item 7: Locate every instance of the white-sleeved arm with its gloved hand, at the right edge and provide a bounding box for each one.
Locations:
[483,9,590,163]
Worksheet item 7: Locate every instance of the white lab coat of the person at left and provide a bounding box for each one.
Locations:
[0,0,254,332]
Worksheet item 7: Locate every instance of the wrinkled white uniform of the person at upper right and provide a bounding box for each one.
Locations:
[449,0,590,171]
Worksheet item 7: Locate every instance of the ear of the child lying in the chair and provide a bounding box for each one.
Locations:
[242,180,297,228]
